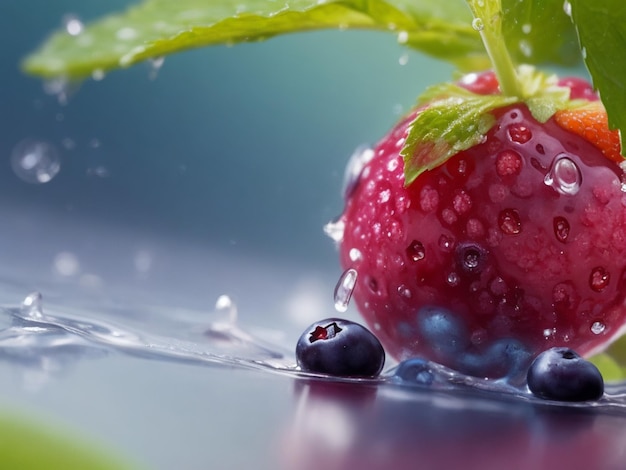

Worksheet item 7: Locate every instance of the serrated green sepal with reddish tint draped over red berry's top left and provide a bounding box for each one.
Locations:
[400,84,518,186]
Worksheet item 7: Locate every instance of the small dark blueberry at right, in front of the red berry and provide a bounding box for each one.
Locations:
[528,347,604,401]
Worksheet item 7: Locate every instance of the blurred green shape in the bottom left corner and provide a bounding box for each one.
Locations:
[0,414,132,470]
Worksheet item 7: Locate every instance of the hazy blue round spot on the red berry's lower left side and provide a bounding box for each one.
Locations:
[417,306,470,360]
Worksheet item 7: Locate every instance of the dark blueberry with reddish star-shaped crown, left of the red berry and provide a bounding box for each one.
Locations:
[296,318,385,377]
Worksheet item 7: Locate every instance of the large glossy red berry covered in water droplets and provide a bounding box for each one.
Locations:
[340,74,626,376]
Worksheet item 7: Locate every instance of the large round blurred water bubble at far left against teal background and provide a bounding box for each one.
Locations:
[11,139,61,184]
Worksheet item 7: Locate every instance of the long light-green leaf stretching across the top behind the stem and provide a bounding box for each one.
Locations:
[23,0,576,78]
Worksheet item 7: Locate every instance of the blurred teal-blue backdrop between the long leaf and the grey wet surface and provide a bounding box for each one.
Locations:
[0,0,452,268]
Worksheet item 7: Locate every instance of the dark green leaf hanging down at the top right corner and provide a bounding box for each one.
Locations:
[570,0,626,158]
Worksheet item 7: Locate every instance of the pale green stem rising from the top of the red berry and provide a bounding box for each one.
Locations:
[467,0,522,98]
